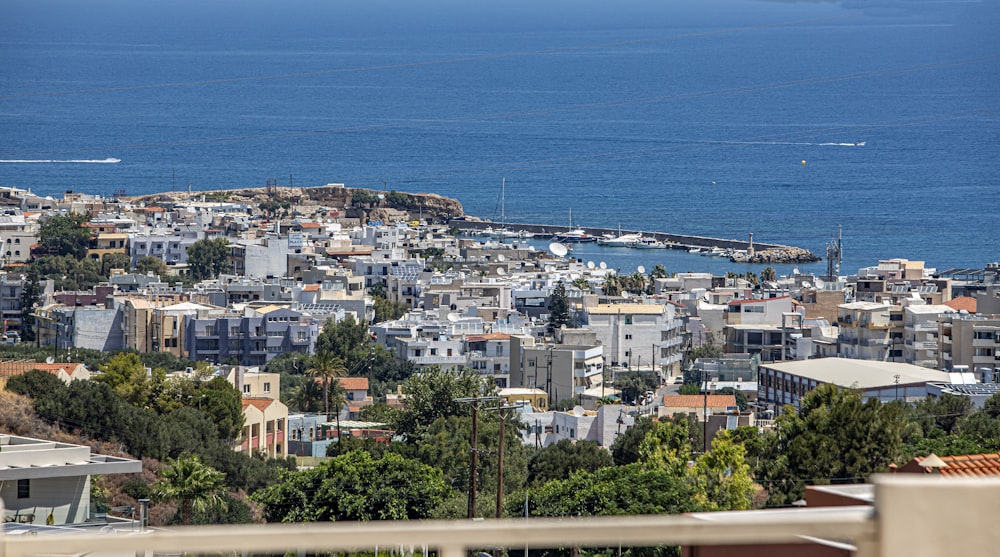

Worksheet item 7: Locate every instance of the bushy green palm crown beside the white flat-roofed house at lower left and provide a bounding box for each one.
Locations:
[153,455,226,524]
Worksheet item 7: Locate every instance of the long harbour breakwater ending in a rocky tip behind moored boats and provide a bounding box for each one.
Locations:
[448,218,820,263]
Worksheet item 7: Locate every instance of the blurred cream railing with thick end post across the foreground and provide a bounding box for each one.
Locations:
[0,475,1000,557]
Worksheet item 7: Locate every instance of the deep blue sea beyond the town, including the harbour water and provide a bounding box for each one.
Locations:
[0,0,1000,274]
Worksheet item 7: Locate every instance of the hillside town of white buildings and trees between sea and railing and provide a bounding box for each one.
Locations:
[0,184,1000,555]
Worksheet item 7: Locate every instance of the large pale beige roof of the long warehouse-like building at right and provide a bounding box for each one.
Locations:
[760,358,951,389]
